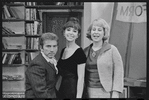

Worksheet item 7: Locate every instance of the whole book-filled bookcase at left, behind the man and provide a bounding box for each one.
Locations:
[2,2,41,98]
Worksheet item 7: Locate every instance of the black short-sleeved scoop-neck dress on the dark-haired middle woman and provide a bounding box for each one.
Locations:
[57,48,86,98]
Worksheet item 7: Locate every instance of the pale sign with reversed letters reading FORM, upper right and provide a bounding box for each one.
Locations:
[116,2,147,23]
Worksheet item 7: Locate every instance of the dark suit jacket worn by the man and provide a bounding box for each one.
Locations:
[25,53,57,98]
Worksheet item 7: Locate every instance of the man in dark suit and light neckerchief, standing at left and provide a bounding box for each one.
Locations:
[25,33,58,98]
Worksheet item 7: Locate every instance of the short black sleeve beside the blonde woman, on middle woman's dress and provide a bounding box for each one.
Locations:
[75,48,87,64]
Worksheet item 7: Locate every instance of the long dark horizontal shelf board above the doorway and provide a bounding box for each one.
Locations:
[33,5,84,9]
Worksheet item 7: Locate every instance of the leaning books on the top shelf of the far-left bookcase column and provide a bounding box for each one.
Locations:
[2,5,24,19]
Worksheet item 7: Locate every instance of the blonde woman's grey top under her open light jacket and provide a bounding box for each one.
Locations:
[85,48,102,88]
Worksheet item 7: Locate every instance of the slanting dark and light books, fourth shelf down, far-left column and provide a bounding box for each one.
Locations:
[2,53,22,64]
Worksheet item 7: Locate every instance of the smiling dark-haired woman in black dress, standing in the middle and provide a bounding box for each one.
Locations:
[57,17,86,98]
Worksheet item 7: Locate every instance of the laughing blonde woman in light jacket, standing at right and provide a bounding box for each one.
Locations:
[84,18,124,98]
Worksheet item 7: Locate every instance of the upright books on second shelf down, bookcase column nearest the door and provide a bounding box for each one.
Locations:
[26,21,41,35]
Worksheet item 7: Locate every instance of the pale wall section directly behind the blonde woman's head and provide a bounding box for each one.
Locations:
[82,2,114,48]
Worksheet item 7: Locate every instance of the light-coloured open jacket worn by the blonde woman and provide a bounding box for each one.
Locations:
[84,43,124,92]
